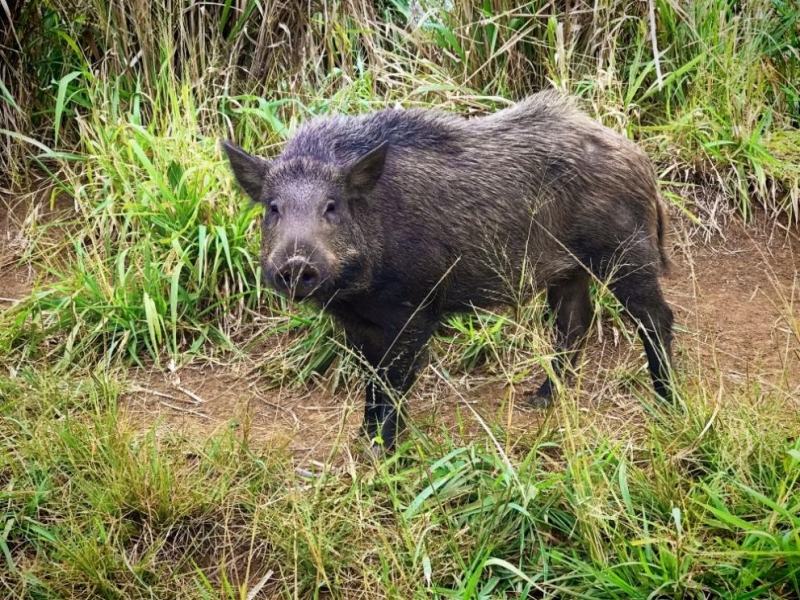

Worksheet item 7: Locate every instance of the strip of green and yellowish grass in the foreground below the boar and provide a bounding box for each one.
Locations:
[0,371,800,598]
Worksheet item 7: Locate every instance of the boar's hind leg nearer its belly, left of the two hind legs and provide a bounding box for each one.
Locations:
[532,269,592,407]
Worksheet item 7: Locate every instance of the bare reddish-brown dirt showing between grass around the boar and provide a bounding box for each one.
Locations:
[0,197,800,464]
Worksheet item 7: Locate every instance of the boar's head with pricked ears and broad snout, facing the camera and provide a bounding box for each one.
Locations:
[223,142,388,303]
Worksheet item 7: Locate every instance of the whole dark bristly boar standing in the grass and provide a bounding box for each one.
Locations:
[224,92,672,449]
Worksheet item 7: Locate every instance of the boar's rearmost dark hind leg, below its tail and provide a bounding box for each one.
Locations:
[611,270,673,401]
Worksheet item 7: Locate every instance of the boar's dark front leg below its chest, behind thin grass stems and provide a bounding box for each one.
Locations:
[344,311,438,456]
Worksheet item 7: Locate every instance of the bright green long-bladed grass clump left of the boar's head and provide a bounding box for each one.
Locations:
[4,80,262,362]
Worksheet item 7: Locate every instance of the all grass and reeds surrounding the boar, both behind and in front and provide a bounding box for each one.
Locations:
[0,0,800,600]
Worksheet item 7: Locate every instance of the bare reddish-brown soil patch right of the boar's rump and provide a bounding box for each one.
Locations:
[664,223,800,397]
